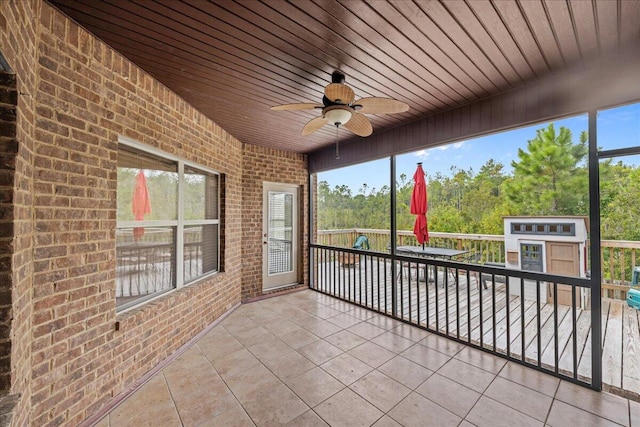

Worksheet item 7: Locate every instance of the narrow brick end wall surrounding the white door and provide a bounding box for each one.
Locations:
[242,144,309,301]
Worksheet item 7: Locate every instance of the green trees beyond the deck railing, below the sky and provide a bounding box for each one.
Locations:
[317,123,640,240]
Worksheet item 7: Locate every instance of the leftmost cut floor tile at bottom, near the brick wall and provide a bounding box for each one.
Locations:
[109,374,182,427]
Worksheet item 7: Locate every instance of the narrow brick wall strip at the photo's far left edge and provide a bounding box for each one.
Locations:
[0,2,38,426]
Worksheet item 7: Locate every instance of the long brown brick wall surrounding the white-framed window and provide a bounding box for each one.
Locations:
[0,0,306,426]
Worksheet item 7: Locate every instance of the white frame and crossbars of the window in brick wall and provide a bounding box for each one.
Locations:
[116,135,223,312]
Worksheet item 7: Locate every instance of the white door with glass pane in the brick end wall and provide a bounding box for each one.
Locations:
[262,182,299,290]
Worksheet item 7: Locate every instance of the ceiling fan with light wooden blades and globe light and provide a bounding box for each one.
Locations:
[271,71,409,136]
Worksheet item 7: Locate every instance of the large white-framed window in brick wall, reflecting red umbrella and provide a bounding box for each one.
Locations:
[116,138,220,310]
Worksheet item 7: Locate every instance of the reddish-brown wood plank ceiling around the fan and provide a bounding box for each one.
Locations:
[49,0,640,153]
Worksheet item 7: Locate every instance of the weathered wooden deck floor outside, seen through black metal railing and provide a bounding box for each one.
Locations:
[316,262,640,400]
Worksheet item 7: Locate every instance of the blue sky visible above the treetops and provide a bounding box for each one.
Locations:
[318,104,640,193]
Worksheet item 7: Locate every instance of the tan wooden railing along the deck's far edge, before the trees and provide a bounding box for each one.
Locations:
[315,228,640,300]
